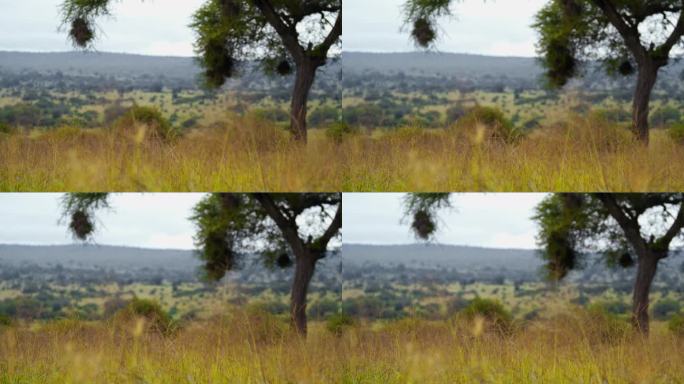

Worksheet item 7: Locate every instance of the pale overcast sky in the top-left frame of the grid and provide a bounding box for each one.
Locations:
[0,0,204,56]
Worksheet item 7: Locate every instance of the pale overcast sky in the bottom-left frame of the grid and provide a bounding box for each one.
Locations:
[0,193,202,249]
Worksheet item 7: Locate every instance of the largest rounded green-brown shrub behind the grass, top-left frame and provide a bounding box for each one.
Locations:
[113,105,178,141]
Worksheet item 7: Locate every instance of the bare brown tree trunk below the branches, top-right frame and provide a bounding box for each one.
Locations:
[632,61,658,145]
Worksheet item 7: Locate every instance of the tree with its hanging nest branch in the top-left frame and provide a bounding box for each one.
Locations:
[62,0,342,142]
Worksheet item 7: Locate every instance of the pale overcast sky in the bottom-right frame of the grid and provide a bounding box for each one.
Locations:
[343,193,545,249]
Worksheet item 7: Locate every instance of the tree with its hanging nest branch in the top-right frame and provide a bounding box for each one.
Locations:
[405,0,684,144]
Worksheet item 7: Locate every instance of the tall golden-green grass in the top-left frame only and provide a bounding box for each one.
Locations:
[0,115,342,192]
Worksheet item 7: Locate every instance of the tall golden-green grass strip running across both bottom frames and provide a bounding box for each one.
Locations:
[0,310,684,383]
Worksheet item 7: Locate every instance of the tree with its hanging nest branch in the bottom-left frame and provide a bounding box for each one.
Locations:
[62,193,342,335]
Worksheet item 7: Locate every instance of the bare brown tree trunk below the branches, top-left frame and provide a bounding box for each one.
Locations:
[290,58,317,143]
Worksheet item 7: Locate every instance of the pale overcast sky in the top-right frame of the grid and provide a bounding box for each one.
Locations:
[343,0,547,57]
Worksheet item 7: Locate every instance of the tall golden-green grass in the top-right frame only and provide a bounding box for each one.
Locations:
[343,116,684,192]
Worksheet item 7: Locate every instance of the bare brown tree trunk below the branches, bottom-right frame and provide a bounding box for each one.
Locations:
[632,251,659,335]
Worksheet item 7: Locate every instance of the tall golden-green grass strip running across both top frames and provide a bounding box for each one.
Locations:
[0,116,684,192]
